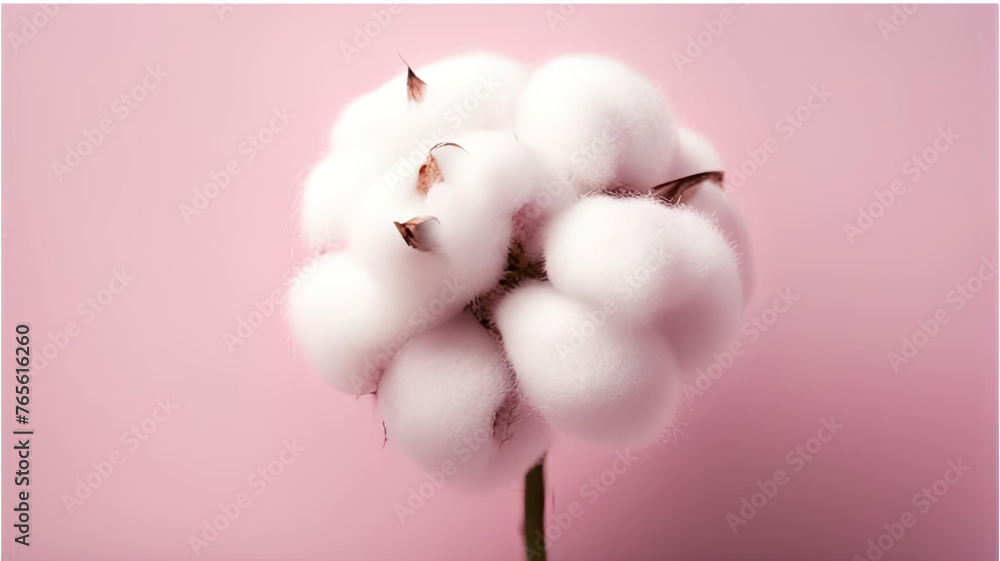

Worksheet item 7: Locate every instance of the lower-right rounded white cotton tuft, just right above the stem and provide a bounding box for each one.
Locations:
[494,283,676,446]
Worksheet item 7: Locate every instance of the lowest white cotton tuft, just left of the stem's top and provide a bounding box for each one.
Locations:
[377,313,548,485]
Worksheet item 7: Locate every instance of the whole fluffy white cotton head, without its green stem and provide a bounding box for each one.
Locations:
[287,53,750,480]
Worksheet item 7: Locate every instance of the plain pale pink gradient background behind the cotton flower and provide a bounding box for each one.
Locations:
[0,4,998,561]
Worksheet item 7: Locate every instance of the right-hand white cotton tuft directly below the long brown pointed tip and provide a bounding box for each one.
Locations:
[545,197,742,368]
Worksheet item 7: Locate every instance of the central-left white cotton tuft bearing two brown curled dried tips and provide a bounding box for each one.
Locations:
[348,132,537,328]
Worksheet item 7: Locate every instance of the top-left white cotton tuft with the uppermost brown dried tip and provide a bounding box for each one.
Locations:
[332,53,524,176]
